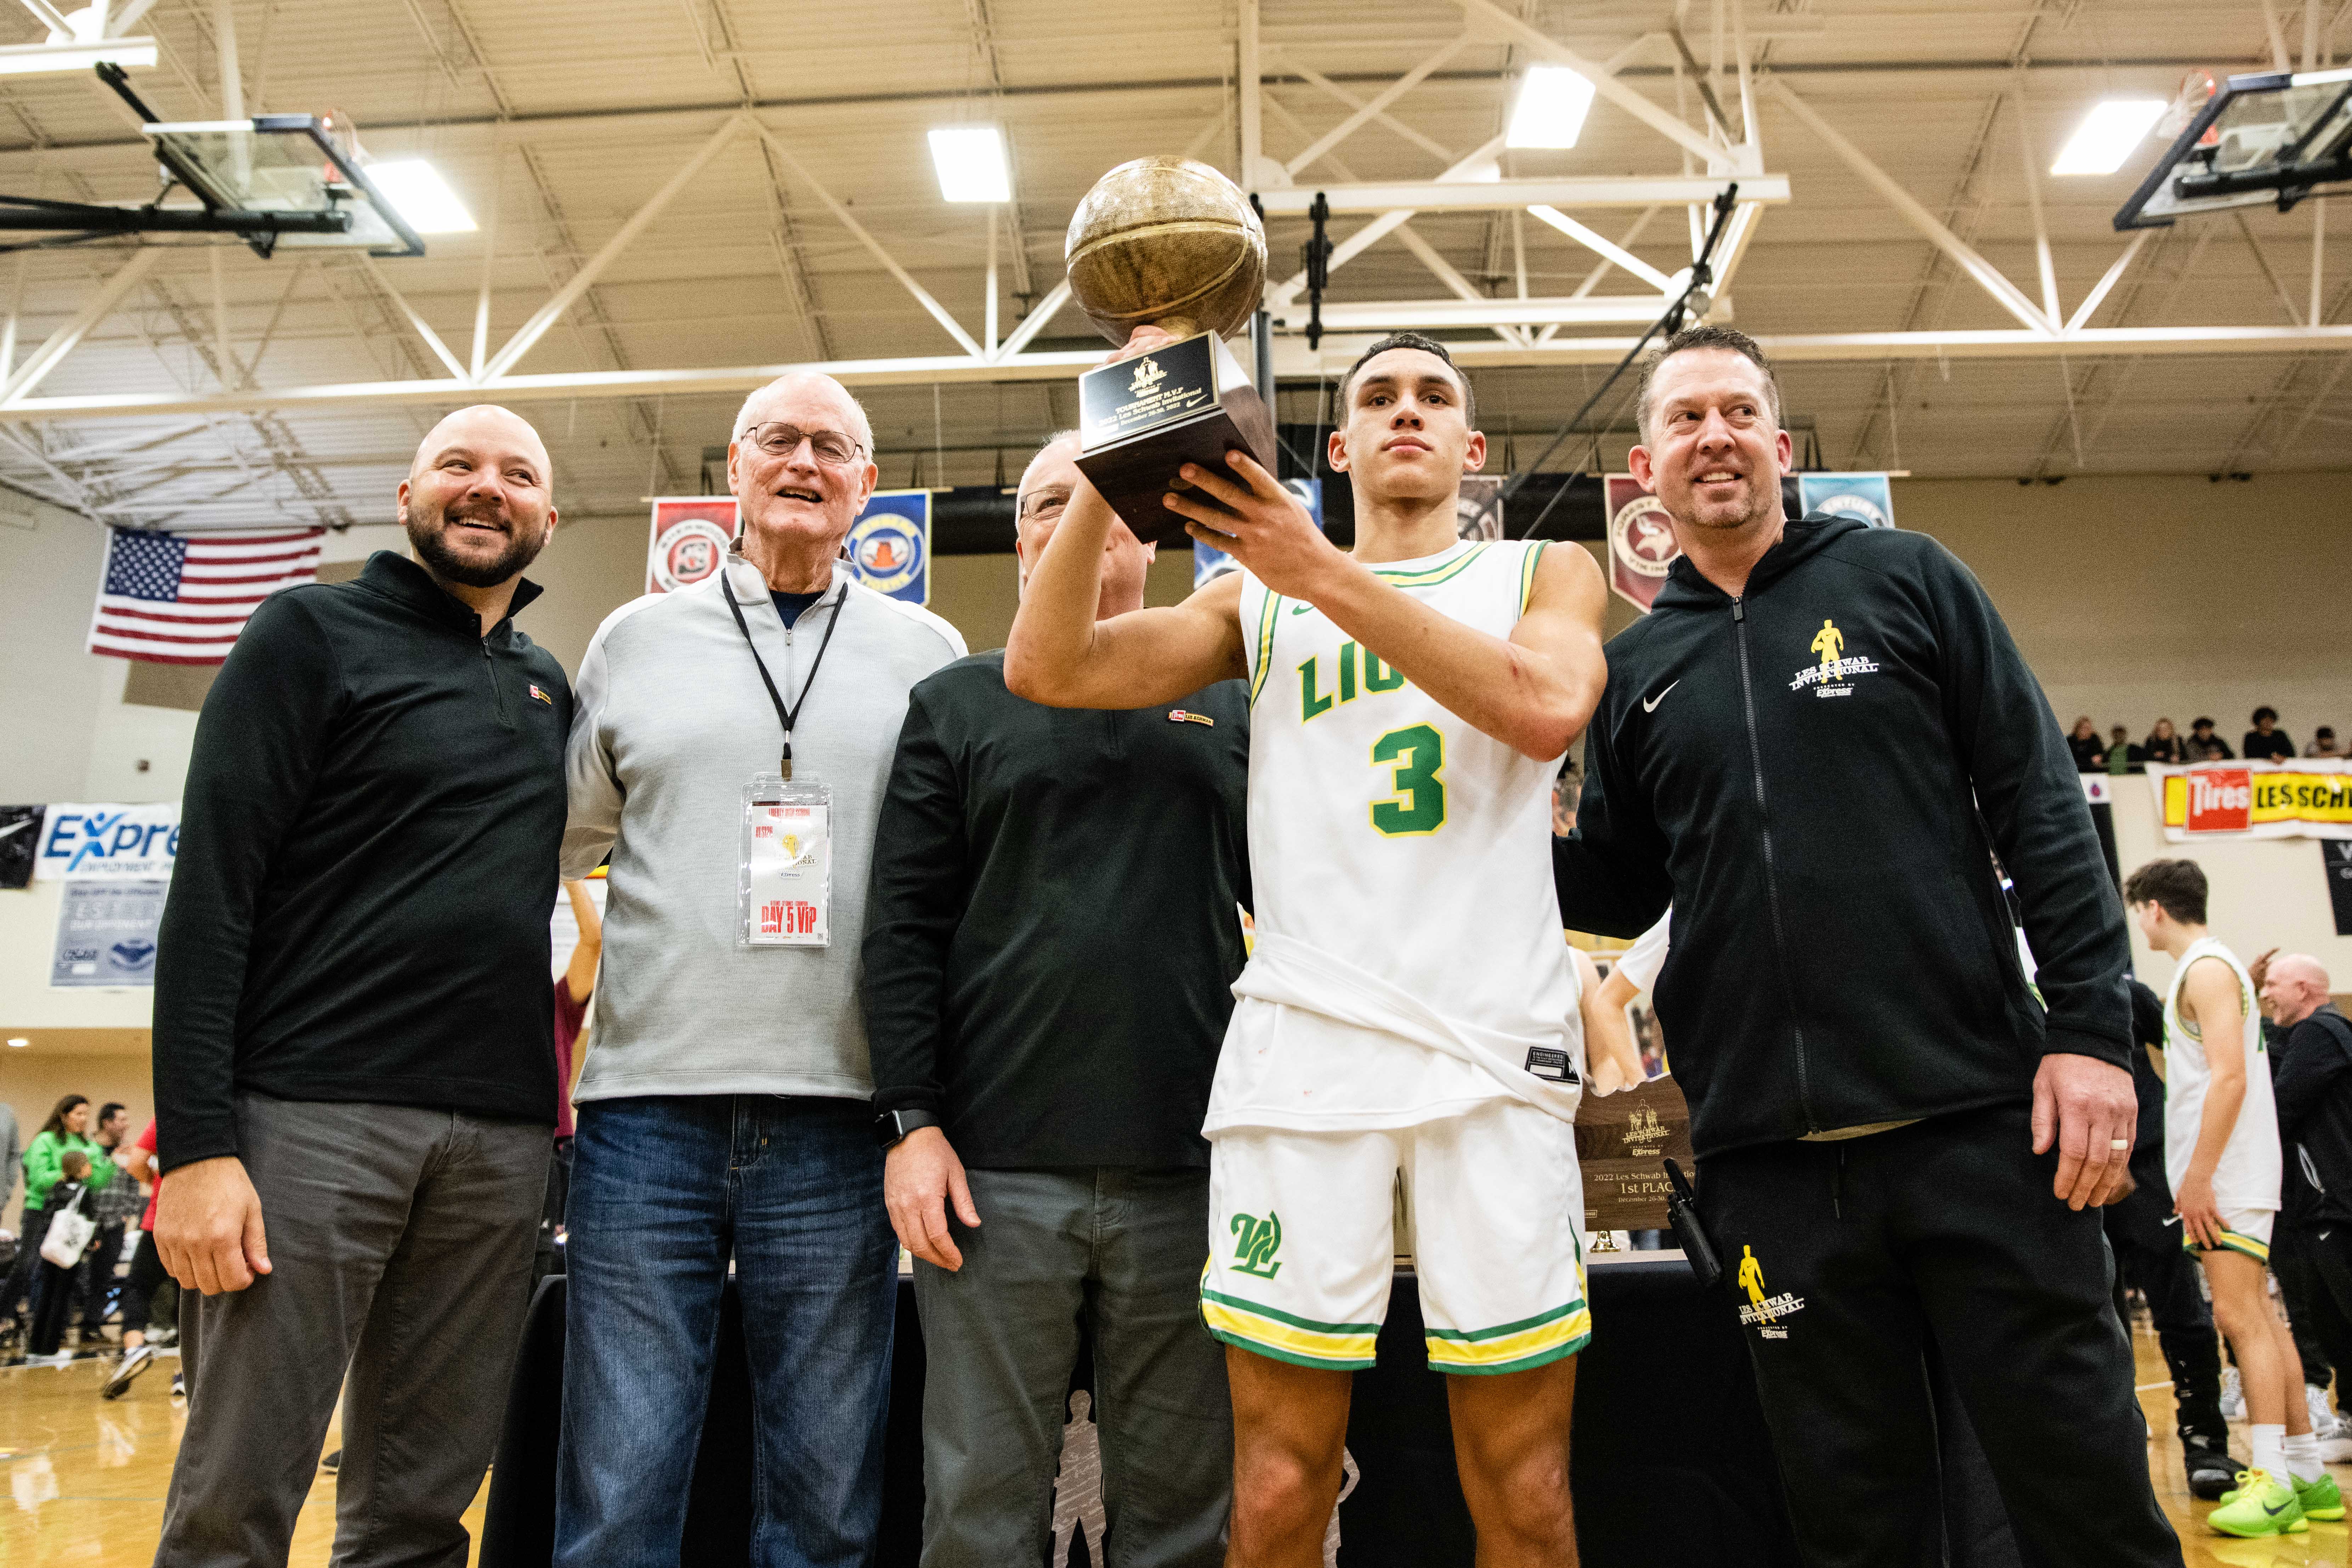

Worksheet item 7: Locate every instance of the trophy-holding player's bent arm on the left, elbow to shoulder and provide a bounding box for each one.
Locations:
[1004,470,1247,708]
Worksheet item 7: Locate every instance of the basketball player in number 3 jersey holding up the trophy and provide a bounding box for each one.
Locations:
[1004,334,1606,1568]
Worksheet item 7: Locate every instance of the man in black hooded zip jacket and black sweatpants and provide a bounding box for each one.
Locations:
[1555,327,2180,1568]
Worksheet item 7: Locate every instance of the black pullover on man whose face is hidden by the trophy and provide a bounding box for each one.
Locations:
[863,651,1249,1171]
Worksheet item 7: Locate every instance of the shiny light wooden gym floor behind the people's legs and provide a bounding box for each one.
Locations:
[0,1328,2352,1568]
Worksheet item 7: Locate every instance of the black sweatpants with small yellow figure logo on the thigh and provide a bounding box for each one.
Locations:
[1698,1105,2180,1568]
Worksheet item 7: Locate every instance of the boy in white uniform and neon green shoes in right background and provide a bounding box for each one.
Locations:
[2124,860,2345,1535]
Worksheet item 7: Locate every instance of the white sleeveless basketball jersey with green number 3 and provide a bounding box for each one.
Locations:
[1204,541,1583,1138]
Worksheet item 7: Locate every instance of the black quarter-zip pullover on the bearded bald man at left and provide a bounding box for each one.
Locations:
[155,550,572,1171]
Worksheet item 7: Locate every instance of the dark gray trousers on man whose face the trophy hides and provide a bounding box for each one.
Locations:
[915,1168,1232,1568]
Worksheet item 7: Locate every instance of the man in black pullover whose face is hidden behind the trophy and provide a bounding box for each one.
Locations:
[866,437,1249,1568]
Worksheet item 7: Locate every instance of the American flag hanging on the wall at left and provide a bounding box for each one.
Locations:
[89,529,324,665]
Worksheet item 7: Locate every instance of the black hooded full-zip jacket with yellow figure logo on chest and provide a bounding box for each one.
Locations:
[1552,517,2131,1156]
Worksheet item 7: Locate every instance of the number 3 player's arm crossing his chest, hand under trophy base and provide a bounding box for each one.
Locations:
[1169,451,1609,762]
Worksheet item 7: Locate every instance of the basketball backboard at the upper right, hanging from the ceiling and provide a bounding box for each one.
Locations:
[2114,70,2352,228]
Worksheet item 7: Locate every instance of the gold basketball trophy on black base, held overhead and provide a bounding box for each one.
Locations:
[1063,158,1275,543]
